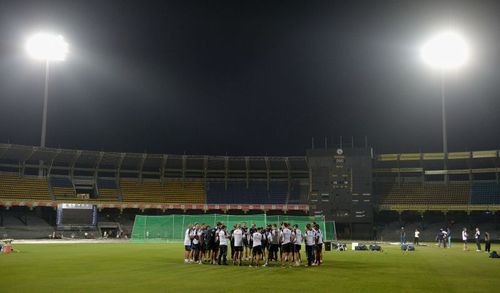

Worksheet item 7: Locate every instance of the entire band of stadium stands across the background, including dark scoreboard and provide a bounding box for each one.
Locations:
[0,144,500,239]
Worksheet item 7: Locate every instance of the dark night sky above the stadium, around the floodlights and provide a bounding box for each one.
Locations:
[0,0,500,155]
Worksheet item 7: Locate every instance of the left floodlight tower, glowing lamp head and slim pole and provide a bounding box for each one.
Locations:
[26,33,69,176]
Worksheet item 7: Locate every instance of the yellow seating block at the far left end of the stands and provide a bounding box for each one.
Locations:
[0,175,51,200]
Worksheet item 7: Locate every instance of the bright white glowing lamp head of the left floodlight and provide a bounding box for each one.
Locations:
[26,33,69,61]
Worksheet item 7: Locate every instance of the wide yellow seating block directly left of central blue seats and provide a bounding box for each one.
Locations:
[120,179,205,204]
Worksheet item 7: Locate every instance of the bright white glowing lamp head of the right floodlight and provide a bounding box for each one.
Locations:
[420,31,469,70]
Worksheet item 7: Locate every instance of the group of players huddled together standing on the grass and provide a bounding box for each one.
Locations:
[184,222,323,267]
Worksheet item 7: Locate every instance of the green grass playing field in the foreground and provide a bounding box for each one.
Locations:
[0,243,500,292]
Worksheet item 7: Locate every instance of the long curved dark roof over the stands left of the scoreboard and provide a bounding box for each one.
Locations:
[0,144,307,170]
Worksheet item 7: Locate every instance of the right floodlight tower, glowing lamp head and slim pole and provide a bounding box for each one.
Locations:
[420,30,469,181]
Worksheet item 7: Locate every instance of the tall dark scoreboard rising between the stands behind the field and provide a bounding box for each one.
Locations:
[307,148,374,234]
